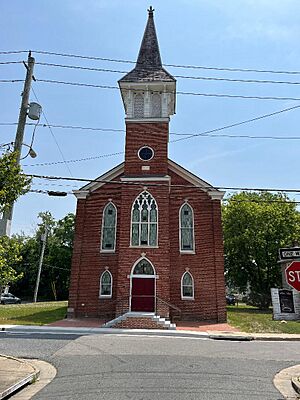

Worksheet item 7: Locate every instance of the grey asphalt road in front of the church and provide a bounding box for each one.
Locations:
[0,333,300,400]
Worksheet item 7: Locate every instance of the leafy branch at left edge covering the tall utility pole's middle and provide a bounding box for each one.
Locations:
[0,152,31,212]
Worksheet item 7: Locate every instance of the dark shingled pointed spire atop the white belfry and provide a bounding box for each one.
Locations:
[120,6,175,82]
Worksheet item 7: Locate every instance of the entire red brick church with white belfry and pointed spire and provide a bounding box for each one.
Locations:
[68,7,226,328]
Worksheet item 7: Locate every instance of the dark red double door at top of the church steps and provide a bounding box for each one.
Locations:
[131,277,155,312]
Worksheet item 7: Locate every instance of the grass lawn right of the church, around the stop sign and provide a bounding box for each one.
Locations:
[227,304,300,334]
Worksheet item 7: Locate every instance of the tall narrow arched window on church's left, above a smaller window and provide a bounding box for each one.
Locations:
[101,202,117,251]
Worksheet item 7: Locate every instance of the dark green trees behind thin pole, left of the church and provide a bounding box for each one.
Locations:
[12,211,75,300]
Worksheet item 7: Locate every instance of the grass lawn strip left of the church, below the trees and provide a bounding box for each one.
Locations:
[0,301,67,325]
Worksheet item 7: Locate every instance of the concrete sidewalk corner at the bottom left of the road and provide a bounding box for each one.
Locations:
[0,355,39,399]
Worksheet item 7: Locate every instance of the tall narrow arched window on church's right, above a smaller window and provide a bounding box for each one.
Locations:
[179,203,195,251]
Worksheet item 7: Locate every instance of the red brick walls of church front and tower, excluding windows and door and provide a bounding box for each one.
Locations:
[69,123,226,322]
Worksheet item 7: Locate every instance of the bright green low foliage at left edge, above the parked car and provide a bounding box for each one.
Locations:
[0,236,23,293]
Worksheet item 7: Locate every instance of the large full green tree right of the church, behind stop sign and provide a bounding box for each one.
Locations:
[222,192,300,309]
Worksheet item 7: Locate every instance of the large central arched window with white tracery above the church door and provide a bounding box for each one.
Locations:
[131,191,157,246]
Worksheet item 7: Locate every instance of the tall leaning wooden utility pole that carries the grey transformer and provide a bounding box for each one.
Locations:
[0,52,35,236]
